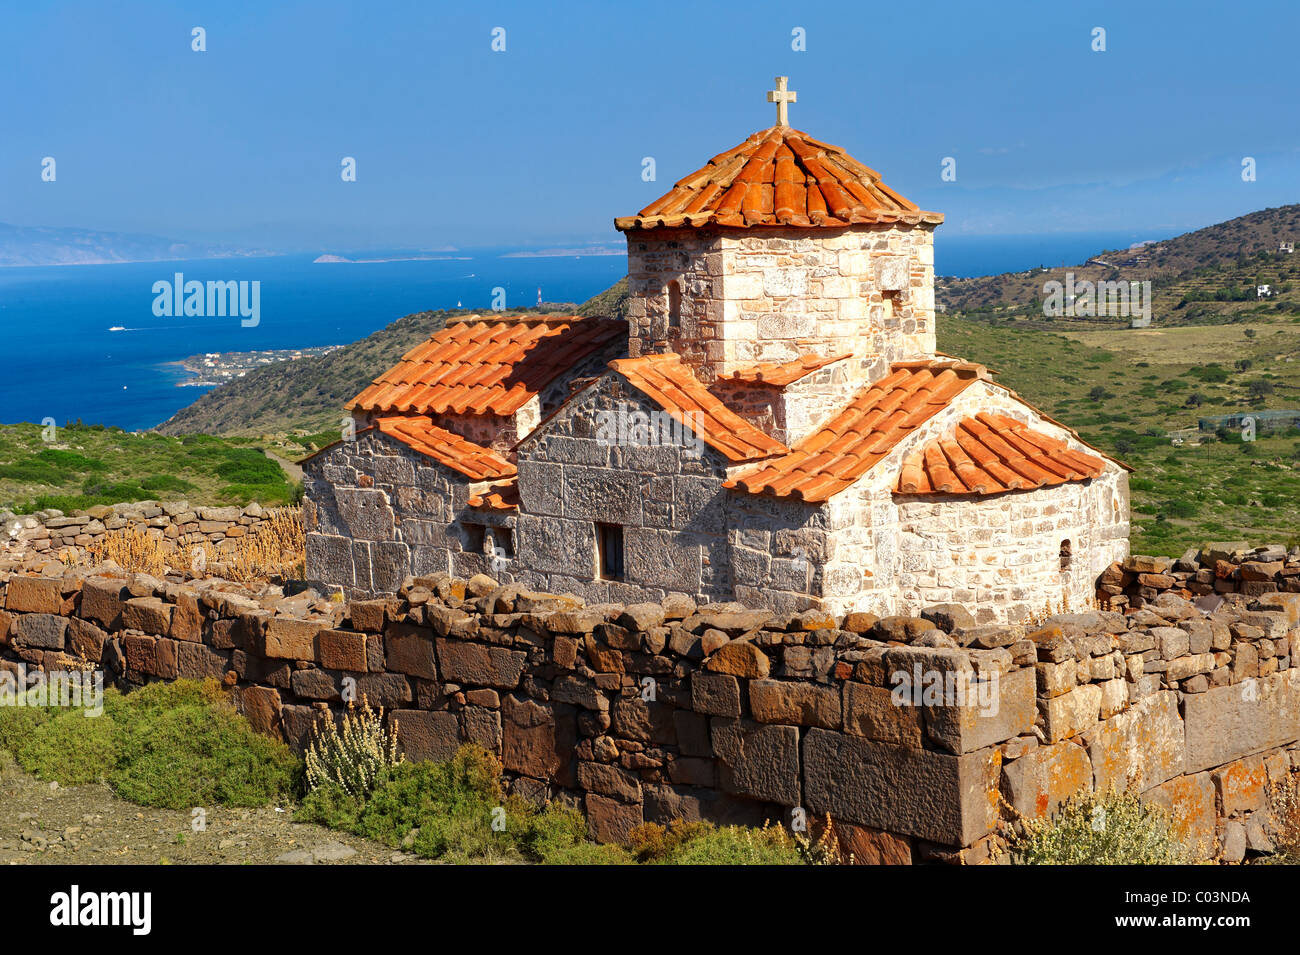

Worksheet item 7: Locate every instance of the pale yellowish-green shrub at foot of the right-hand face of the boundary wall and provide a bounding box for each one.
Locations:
[1010,791,1190,865]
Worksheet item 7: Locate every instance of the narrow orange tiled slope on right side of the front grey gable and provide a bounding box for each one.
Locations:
[610,355,789,461]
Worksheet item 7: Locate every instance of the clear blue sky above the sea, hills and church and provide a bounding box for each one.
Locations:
[0,0,1300,249]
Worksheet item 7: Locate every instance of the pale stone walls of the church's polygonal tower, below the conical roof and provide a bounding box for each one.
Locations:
[628,226,935,399]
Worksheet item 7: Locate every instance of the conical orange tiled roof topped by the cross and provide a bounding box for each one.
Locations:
[614,126,944,230]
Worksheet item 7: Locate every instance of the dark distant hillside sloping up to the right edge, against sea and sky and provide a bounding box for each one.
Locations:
[935,205,1300,329]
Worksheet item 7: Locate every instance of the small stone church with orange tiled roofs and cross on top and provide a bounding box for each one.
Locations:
[304,78,1128,622]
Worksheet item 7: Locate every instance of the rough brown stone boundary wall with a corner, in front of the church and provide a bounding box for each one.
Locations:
[0,548,1300,863]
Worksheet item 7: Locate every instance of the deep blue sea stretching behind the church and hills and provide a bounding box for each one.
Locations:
[0,233,1158,430]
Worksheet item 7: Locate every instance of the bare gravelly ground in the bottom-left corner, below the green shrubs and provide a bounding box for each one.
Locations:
[0,752,421,865]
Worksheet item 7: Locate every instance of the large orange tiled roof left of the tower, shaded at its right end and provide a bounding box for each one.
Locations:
[347,316,627,414]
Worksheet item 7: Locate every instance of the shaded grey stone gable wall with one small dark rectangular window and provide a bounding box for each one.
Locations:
[510,374,818,609]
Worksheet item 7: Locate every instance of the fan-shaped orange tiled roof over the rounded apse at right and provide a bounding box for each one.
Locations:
[894,413,1106,494]
